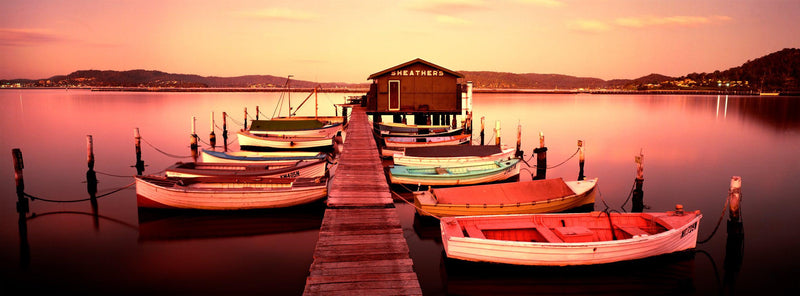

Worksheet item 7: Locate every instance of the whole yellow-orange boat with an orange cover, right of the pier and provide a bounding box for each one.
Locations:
[414,178,597,217]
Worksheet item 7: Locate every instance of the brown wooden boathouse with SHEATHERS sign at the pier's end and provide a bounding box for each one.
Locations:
[363,59,465,125]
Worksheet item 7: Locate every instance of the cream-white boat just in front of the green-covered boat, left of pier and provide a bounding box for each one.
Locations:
[236,131,333,150]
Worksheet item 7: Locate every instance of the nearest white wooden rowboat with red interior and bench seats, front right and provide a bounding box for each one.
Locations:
[440,211,702,266]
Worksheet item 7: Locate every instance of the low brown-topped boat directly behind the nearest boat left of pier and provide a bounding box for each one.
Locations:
[165,159,327,178]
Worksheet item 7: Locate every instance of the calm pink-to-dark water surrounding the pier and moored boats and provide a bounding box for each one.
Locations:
[0,90,800,295]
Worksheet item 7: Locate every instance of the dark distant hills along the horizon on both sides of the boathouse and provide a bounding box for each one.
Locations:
[0,48,800,92]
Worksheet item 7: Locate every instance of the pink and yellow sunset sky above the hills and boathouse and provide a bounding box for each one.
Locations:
[0,0,800,83]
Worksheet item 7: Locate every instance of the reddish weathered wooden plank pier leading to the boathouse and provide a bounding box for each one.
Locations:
[303,107,422,295]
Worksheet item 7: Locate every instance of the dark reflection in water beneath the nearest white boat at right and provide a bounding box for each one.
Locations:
[441,251,695,295]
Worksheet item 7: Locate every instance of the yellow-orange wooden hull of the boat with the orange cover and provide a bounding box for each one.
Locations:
[414,179,597,217]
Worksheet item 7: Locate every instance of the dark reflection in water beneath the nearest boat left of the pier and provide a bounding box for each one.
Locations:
[139,202,325,242]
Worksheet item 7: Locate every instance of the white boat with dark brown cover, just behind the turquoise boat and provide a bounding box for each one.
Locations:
[392,145,515,166]
